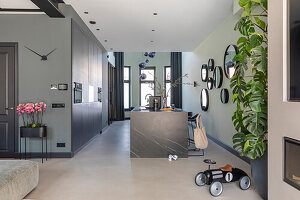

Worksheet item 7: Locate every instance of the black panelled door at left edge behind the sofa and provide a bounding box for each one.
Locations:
[0,43,18,157]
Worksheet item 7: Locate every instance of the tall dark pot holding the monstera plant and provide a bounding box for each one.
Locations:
[251,151,268,200]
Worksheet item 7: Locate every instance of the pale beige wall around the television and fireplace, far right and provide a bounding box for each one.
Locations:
[268,0,300,200]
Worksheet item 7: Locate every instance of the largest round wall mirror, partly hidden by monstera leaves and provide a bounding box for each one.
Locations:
[224,45,238,79]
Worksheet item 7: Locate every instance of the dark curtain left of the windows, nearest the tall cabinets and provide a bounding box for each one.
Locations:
[114,52,125,121]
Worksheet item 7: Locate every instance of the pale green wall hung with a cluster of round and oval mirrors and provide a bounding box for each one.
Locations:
[182,12,240,146]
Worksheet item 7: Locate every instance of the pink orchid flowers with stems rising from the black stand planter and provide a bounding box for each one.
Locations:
[17,102,47,128]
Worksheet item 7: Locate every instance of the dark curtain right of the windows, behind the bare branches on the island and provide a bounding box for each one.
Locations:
[171,52,182,108]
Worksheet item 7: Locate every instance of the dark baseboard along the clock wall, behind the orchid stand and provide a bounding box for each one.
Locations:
[0,152,73,158]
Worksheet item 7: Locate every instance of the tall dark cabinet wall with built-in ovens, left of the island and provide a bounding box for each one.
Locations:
[72,20,103,152]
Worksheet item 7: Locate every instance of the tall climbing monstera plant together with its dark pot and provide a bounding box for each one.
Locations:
[230,0,268,199]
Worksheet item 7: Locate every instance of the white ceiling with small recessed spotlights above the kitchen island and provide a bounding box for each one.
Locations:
[64,0,233,52]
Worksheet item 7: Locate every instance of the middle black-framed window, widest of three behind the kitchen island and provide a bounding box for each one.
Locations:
[140,67,155,106]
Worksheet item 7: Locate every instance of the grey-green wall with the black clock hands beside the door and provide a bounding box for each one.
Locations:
[0,14,71,153]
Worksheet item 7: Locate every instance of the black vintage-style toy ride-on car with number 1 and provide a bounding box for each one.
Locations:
[195,159,251,197]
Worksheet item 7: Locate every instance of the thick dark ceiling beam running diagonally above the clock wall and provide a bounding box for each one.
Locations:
[31,0,65,18]
